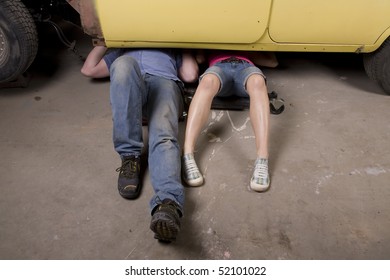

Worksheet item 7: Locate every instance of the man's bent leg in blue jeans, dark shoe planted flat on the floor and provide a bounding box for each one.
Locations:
[110,56,145,198]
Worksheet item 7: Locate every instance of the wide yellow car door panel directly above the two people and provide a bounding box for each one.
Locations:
[95,0,272,46]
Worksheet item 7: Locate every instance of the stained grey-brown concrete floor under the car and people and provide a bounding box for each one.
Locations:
[0,24,390,259]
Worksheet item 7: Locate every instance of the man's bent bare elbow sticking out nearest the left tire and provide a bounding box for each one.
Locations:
[81,46,110,78]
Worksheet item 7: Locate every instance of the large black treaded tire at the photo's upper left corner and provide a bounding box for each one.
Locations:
[0,0,38,83]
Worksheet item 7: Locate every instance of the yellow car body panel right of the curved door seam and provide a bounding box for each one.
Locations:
[269,0,390,45]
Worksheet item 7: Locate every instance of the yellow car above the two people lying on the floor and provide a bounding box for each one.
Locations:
[0,0,390,94]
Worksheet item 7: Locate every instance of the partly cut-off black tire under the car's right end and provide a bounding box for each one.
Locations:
[363,38,390,95]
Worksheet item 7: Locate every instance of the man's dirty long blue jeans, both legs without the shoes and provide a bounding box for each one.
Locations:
[110,56,184,213]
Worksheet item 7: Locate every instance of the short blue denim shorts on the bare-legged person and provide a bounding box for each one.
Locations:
[200,61,266,97]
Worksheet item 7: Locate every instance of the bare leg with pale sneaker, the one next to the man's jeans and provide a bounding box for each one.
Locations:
[182,73,221,187]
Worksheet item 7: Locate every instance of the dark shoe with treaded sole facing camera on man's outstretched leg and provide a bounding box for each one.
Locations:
[150,212,180,242]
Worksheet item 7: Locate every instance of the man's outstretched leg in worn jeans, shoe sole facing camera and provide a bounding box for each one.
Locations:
[145,76,184,242]
